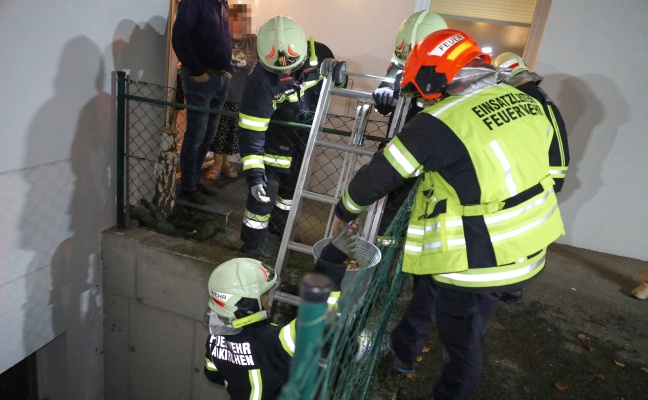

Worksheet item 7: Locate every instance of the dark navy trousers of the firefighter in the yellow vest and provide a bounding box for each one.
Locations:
[391,275,500,400]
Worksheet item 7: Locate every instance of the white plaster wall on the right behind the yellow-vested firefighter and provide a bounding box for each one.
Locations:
[536,0,648,260]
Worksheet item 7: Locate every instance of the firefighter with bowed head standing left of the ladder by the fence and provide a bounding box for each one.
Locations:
[237,16,346,259]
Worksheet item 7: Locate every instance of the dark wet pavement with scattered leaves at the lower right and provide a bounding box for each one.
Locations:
[396,244,648,400]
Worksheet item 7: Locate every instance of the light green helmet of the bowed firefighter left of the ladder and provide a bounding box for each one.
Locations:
[257,15,308,73]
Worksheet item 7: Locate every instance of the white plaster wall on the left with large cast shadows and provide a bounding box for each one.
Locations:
[0,0,168,400]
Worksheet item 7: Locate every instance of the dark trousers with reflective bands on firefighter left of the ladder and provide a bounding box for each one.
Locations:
[241,168,297,246]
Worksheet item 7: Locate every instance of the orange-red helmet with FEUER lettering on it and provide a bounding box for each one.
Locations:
[401,29,491,100]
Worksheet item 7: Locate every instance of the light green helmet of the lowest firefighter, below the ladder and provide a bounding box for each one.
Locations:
[207,258,277,320]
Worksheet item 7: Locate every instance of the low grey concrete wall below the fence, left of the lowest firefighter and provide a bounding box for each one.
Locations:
[102,229,230,400]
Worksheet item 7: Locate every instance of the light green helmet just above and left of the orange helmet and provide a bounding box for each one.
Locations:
[392,10,448,67]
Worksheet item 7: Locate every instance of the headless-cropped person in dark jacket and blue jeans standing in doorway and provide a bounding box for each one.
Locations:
[171,0,232,204]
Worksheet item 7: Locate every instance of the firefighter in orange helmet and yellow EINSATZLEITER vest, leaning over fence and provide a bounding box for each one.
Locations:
[333,29,564,400]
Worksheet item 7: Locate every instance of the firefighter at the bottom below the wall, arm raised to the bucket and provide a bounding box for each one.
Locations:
[204,226,358,399]
